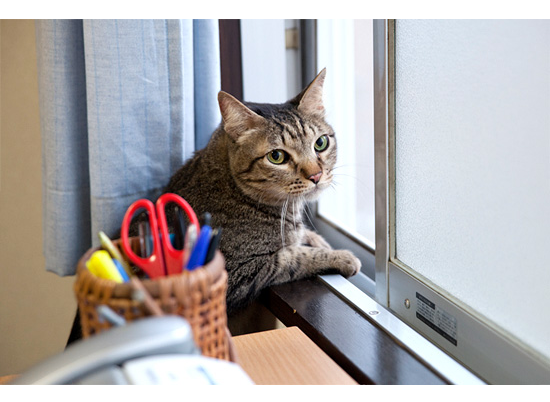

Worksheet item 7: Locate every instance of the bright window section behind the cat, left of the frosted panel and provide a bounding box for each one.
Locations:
[241,19,382,294]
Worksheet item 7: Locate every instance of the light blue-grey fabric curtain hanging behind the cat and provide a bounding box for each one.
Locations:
[36,20,221,275]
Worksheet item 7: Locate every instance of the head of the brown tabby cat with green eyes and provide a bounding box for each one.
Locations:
[218,69,336,205]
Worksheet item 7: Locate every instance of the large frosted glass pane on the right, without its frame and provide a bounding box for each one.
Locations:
[396,20,550,358]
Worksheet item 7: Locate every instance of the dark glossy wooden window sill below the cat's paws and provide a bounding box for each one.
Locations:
[261,278,448,385]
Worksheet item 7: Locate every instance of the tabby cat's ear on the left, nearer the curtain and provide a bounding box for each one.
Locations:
[218,91,265,141]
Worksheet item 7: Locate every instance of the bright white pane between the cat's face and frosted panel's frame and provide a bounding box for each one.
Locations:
[317,20,375,249]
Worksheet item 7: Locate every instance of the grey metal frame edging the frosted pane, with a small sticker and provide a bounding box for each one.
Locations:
[374,20,550,384]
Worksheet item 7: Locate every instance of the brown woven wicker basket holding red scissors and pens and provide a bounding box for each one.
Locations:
[74,238,237,362]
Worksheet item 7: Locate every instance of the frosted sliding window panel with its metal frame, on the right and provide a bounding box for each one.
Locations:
[375,20,550,384]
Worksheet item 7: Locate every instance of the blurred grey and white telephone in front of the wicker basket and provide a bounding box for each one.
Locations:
[12,316,252,385]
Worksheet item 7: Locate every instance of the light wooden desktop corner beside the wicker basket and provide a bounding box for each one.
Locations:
[233,327,357,385]
